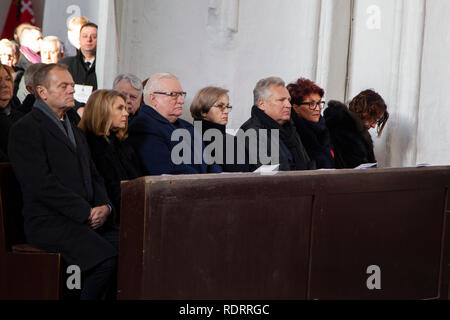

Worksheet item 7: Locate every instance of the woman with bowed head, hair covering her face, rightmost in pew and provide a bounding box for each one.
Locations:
[324,89,389,168]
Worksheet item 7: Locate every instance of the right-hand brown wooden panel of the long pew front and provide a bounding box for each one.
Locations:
[310,186,444,299]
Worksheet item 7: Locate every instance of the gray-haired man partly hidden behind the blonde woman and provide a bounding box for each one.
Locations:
[113,73,143,123]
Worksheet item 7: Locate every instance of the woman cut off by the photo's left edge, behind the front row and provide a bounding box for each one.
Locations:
[0,64,24,161]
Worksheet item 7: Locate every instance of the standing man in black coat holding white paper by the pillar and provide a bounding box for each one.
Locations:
[59,22,98,107]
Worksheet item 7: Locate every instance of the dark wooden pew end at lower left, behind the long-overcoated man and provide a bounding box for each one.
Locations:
[0,163,62,300]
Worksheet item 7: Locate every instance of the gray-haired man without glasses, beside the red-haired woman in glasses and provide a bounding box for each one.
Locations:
[238,77,315,171]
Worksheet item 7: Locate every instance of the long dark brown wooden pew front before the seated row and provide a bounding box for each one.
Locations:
[118,167,450,299]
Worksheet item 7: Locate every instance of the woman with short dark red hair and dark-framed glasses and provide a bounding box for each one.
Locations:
[287,78,335,169]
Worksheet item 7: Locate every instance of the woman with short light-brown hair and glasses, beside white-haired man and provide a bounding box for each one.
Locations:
[190,87,247,172]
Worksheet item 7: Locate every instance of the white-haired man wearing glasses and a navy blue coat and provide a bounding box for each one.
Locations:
[128,73,221,175]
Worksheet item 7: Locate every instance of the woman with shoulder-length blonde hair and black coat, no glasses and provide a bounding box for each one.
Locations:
[79,90,143,223]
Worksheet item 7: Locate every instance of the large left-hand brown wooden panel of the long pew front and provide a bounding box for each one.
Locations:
[144,179,312,299]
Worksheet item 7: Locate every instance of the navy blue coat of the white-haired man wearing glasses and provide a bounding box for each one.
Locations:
[128,105,222,175]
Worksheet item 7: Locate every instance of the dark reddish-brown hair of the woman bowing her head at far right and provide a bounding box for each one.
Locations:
[348,89,389,136]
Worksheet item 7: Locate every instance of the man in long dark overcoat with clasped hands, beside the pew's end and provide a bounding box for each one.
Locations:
[8,64,118,299]
